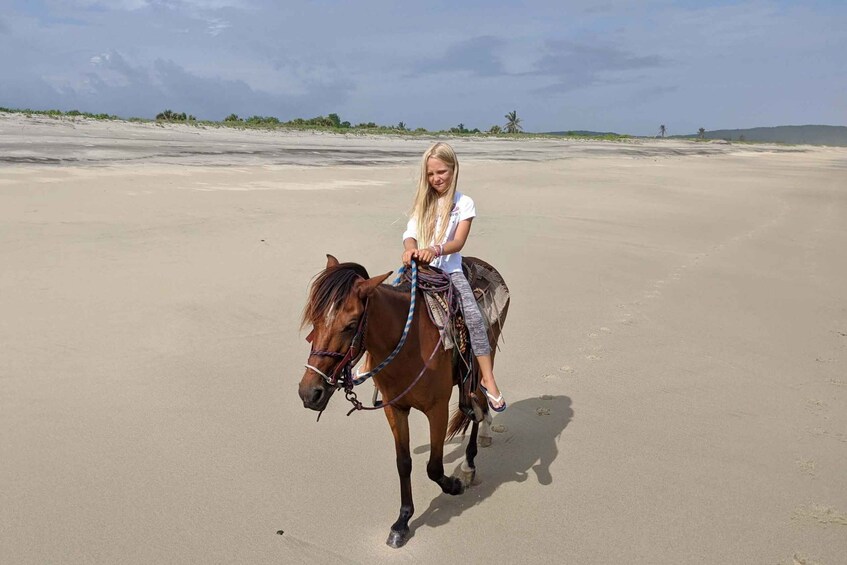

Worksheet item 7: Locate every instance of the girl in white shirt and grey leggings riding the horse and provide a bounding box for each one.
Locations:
[403,143,506,412]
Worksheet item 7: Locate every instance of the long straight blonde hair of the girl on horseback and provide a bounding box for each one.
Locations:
[409,142,459,247]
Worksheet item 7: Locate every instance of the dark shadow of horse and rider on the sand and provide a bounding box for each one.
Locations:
[409,395,573,535]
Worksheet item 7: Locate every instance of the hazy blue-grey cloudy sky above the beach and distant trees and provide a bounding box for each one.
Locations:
[0,0,847,135]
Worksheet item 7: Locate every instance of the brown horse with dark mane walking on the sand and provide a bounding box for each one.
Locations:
[299,255,508,548]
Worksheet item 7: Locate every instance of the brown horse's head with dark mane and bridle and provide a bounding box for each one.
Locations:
[299,255,391,411]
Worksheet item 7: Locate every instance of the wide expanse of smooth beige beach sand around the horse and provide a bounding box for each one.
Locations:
[0,115,847,565]
